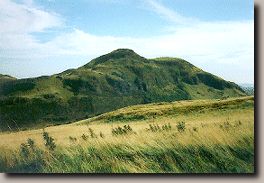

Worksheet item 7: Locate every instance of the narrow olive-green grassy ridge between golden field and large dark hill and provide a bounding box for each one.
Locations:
[80,96,254,124]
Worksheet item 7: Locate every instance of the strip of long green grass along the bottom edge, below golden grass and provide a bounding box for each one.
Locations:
[0,137,254,173]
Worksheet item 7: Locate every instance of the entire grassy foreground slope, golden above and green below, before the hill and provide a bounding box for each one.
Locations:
[0,97,254,173]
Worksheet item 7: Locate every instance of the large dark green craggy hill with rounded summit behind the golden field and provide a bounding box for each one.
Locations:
[0,49,246,130]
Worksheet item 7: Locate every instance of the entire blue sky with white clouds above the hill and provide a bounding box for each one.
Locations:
[0,0,254,83]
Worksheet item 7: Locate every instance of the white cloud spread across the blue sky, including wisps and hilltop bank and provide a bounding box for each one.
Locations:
[0,0,254,82]
